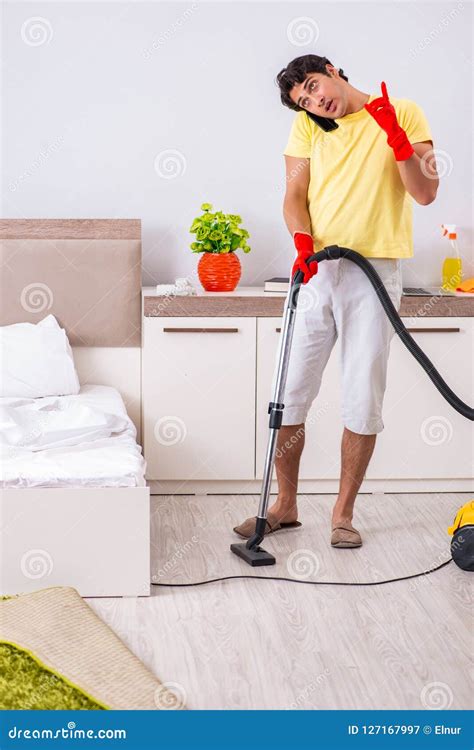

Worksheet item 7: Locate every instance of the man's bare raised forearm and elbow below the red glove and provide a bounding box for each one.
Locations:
[397,141,439,206]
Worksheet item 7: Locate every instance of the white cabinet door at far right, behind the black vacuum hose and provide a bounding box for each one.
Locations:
[366,318,474,480]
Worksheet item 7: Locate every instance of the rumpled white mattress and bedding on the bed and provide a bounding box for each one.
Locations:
[0,385,146,488]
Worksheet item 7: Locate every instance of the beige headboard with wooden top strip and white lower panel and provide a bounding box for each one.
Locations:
[0,219,141,434]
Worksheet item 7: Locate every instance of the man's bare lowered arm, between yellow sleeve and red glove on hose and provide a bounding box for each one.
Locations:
[283,156,311,236]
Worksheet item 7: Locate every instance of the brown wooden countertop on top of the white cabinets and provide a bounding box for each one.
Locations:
[142,286,474,318]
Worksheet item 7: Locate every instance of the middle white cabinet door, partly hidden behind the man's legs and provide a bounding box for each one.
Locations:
[256,318,342,479]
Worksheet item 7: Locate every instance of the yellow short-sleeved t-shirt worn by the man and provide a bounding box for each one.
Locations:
[283,94,433,258]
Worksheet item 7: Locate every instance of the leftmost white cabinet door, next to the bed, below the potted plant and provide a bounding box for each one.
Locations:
[142,317,256,480]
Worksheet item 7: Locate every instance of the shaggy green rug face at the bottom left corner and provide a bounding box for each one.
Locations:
[0,641,107,711]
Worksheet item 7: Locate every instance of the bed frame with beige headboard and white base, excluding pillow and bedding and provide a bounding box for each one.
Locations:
[0,219,150,597]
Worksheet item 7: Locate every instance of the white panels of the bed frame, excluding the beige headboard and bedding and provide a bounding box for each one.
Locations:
[0,347,150,597]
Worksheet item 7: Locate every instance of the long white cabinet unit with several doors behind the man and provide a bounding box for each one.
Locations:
[142,290,474,494]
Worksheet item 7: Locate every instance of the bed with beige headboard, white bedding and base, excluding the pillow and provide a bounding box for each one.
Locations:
[0,219,150,597]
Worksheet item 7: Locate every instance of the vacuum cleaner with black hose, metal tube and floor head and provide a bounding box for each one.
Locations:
[230,245,474,570]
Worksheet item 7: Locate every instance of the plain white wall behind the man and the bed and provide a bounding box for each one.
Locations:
[1,0,474,285]
